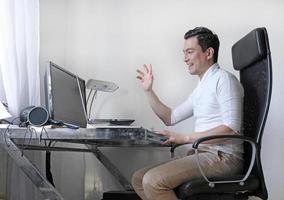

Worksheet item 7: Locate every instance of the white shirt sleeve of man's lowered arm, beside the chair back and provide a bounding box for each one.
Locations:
[217,74,244,132]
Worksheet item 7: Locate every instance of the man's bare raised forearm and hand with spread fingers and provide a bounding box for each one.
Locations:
[137,64,172,125]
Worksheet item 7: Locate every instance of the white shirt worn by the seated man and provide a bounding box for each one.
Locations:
[171,63,244,157]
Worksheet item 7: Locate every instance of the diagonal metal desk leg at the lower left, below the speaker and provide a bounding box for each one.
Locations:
[0,135,64,200]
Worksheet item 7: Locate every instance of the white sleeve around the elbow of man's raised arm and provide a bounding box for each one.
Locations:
[171,96,193,125]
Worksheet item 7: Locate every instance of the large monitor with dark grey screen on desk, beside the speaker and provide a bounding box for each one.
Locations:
[45,62,87,128]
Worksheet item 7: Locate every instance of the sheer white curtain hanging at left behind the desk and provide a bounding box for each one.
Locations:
[0,0,40,200]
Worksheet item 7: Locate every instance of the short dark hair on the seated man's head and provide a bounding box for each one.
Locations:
[184,27,220,62]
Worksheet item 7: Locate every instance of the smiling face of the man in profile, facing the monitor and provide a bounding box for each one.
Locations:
[183,36,212,78]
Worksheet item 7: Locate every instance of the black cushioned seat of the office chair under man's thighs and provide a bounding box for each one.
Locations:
[176,175,259,199]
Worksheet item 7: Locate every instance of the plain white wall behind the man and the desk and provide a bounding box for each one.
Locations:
[40,0,284,200]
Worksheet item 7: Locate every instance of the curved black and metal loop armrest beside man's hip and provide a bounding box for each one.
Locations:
[192,135,258,187]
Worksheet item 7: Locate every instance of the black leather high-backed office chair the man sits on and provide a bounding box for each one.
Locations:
[176,28,272,200]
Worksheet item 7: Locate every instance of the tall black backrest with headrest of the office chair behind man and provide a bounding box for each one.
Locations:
[232,28,272,199]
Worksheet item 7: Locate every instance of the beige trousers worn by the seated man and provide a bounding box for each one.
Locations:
[132,151,243,200]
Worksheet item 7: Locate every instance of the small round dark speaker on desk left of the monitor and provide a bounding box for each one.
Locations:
[20,106,49,126]
